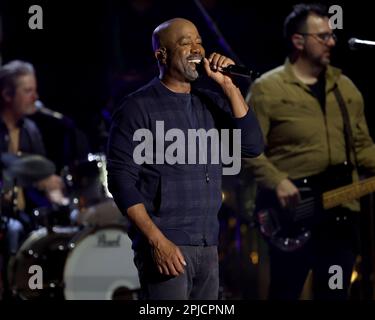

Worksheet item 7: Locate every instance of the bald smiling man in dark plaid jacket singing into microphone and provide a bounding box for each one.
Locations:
[108,18,263,299]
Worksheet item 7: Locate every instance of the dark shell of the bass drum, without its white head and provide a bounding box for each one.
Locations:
[8,227,78,300]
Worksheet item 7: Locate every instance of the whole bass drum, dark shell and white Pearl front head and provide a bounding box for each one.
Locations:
[8,225,140,300]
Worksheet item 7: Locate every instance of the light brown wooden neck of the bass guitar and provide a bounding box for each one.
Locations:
[323,177,375,209]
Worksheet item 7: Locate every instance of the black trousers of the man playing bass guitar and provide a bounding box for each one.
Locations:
[269,209,359,300]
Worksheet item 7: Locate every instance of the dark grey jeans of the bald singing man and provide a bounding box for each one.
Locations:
[134,246,219,300]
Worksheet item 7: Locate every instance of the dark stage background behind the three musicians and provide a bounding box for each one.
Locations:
[0,0,375,299]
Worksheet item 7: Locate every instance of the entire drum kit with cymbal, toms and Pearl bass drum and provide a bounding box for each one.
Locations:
[0,154,140,300]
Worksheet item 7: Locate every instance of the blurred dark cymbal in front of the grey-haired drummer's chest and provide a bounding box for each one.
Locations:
[1,153,56,187]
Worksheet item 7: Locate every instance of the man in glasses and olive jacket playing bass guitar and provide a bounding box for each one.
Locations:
[246,4,375,299]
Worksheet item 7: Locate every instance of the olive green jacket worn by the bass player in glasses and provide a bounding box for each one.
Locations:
[245,59,375,210]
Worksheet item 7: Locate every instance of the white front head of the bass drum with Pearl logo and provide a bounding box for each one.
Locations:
[64,225,140,300]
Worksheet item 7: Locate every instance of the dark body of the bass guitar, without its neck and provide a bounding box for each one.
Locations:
[255,164,353,251]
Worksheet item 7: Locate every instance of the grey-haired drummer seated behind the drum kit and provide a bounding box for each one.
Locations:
[0,60,65,254]
